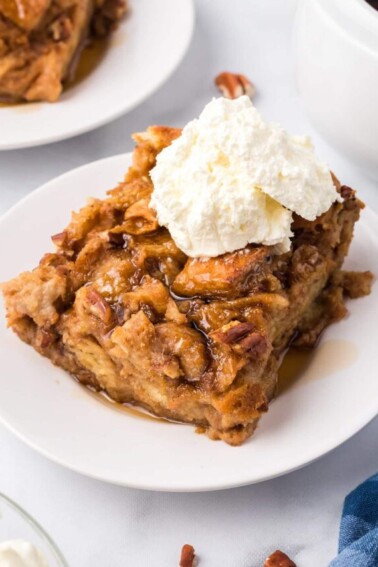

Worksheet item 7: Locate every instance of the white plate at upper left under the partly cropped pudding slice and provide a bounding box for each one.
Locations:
[0,0,194,150]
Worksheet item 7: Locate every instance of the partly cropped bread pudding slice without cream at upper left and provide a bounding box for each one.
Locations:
[0,0,126,102]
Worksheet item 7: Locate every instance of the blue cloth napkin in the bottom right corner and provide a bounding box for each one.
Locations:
[329,474,378,567]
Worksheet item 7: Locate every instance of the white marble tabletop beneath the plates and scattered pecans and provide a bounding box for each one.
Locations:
[0,0,378,567]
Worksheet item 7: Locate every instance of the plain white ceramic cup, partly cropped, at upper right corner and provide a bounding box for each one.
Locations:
[295,0,378,176]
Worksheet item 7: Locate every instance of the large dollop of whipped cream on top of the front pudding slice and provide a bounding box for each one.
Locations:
[150,96,338,257]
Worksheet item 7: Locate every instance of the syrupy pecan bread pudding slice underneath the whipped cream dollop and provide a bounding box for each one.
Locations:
[3,127,369,445]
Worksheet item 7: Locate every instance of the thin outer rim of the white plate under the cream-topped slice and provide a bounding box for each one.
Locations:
[0,152,378,493]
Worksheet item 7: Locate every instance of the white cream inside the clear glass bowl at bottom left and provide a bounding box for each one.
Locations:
[0,539,48,567]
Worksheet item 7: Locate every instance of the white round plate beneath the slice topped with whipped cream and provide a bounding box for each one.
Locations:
[0,155,378,491]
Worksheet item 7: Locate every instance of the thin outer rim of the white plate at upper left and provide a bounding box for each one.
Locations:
[0,0,195,152]
